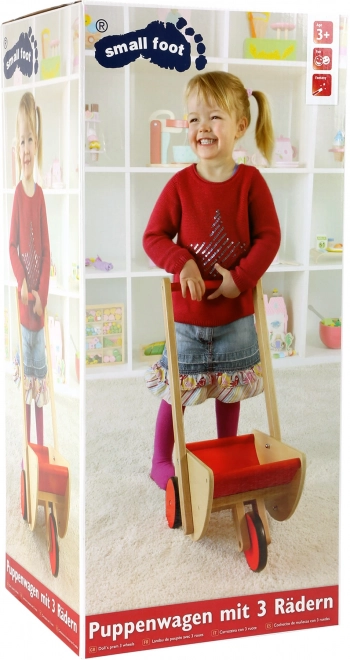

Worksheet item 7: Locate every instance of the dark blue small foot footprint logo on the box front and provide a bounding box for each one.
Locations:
[95,18,207,72]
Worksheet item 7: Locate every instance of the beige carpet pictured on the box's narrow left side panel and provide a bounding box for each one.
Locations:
[5,376,79,612]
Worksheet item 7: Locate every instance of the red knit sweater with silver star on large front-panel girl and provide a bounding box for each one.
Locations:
[143,165,281,327]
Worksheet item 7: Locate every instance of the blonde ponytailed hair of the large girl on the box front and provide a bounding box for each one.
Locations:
[185,71,275,163]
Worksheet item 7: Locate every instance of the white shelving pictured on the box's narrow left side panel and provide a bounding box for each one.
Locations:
[2,4,81,397]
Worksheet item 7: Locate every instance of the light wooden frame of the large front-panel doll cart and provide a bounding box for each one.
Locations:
[162,278,306,551]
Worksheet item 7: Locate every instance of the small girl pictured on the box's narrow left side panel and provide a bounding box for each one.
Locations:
[10,92,50,444]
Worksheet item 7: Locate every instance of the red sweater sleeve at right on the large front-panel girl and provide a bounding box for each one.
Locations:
[231,170,281,293]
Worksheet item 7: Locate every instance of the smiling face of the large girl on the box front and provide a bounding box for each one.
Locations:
[188,91,248,165]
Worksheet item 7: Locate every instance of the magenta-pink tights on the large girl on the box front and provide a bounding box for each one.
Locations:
[150,399,240,490]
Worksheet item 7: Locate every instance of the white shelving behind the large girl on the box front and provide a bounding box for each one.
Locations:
[85,4,346,378]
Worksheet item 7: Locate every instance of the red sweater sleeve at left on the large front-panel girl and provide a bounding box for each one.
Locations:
[143,177,193,274]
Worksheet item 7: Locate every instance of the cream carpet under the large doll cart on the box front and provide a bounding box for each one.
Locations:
[86,364,340,614]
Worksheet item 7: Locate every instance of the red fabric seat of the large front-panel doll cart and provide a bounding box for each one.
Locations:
[186,433,301,498]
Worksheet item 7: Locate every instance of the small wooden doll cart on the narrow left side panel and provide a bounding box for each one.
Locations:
[17,294,70,577]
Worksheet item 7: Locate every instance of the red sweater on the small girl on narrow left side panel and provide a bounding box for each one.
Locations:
[10,181,50,331]
